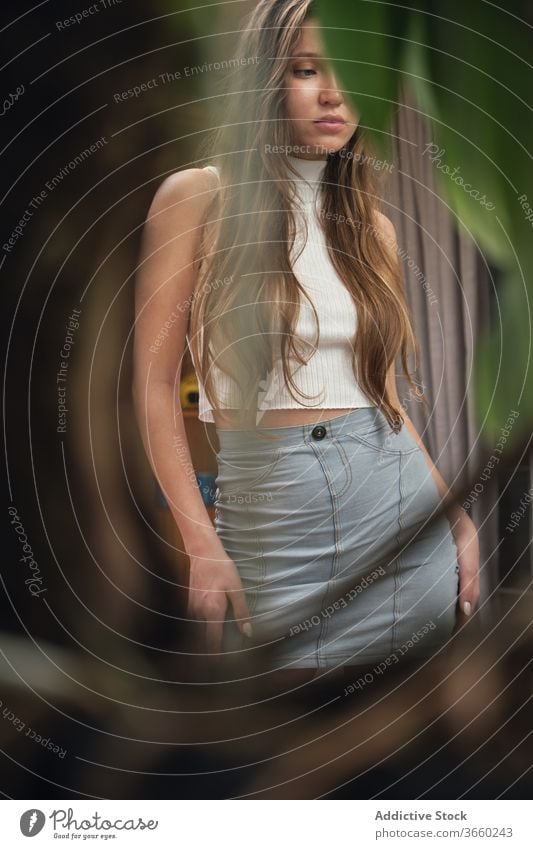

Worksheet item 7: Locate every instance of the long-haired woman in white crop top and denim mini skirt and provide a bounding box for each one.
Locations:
[134,0,479,672]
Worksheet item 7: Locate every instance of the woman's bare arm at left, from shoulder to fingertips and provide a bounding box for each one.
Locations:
[133,168,251,651]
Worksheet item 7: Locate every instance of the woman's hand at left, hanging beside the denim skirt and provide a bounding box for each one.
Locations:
[187,544,252,653]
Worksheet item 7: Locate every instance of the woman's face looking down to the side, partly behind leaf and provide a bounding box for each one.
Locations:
[285,19,359,159]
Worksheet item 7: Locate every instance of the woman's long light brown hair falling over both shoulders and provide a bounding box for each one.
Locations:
[189,0,418,438]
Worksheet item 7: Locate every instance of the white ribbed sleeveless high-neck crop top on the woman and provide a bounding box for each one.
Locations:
[187,155,374,424]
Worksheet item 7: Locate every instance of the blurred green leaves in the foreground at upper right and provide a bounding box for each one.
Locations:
[318,0,533,440]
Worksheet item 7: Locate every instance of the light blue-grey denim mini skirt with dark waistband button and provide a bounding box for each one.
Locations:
[215,407,459,669]
